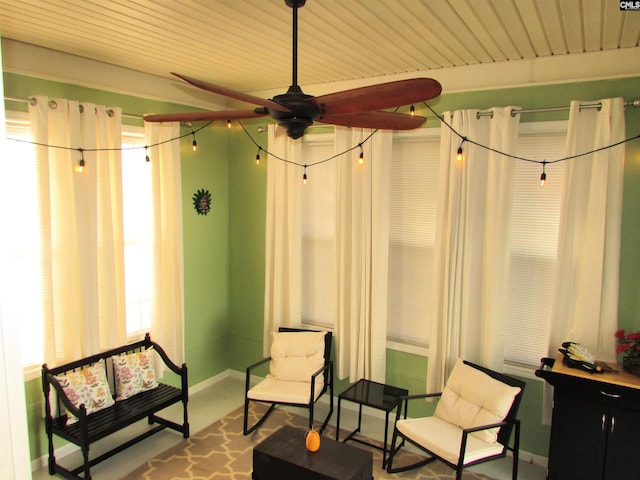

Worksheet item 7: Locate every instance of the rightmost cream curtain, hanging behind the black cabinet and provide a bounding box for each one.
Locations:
[549,98,625,361]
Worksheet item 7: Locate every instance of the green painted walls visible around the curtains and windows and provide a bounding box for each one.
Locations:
[4,69,640,464]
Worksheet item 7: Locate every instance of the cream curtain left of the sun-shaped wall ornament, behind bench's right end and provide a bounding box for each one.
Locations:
[144,122,185,363]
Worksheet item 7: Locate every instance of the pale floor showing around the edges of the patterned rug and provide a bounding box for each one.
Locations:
[32,374,546,480]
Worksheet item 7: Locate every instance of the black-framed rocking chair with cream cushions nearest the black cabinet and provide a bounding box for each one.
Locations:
[387,359,525,480]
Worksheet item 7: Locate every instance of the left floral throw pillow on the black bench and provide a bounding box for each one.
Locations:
[55,359,114,425]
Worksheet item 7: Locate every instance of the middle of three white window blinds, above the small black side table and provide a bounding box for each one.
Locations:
[387,129,440,347]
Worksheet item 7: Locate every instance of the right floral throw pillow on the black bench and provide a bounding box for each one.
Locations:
[111,348,158,400]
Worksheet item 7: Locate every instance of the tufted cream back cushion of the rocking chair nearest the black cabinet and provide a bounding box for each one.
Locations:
[434,359,520,442]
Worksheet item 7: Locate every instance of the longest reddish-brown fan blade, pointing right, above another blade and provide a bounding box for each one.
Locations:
[308,78,442,115]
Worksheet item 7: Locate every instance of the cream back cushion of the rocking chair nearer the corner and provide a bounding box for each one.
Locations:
[269,332,326,384]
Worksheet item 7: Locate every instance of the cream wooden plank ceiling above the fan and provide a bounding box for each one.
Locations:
[0,0,640,91]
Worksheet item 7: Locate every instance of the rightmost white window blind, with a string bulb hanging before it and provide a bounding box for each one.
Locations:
[504,122,567,365]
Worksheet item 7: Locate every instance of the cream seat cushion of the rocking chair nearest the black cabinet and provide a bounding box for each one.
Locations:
[396,416,504,465]
